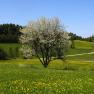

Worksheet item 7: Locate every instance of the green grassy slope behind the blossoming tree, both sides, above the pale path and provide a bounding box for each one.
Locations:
[0,40,94,54]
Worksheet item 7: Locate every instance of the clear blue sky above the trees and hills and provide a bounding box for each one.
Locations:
[0,0,94,37]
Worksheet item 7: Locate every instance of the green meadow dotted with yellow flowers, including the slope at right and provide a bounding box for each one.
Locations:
[0,41,94,94]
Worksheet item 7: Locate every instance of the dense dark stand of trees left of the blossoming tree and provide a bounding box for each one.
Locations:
[0,23,22,43]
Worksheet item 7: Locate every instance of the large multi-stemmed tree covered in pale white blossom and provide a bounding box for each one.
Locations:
[20,17,69,67]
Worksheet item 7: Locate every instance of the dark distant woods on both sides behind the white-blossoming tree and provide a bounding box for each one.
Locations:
[0,24,94,43]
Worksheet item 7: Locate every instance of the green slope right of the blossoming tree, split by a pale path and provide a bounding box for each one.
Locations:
[67,40,94,61]
